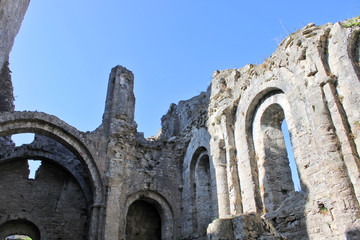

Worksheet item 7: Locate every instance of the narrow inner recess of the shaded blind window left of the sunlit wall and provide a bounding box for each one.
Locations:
[195,153,213,232]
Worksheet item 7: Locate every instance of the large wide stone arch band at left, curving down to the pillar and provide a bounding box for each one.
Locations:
[0,112,104,239]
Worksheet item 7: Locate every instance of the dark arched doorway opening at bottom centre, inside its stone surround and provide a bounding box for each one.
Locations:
[126,200,161,240]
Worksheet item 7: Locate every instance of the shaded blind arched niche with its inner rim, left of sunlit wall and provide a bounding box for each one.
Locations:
[190,147,213,232]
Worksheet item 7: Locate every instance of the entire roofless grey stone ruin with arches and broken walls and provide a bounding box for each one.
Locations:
[0,0,360,240]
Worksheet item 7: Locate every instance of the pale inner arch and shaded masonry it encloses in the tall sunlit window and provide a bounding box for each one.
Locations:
[252,95,297,212]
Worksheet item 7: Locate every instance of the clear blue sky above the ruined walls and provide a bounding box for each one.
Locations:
[10,0,360,136]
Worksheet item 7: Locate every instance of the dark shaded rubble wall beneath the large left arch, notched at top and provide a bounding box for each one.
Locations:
[0,159,89,240]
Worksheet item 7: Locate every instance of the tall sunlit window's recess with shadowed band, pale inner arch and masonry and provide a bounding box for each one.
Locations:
[246,89,300,211]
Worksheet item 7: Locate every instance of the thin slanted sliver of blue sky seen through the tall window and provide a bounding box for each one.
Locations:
[281,118,301,192]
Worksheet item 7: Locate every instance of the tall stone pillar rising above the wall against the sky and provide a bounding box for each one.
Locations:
[103,66,136,240]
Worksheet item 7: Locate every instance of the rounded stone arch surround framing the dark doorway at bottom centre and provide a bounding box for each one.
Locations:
[124,190,174,240]
